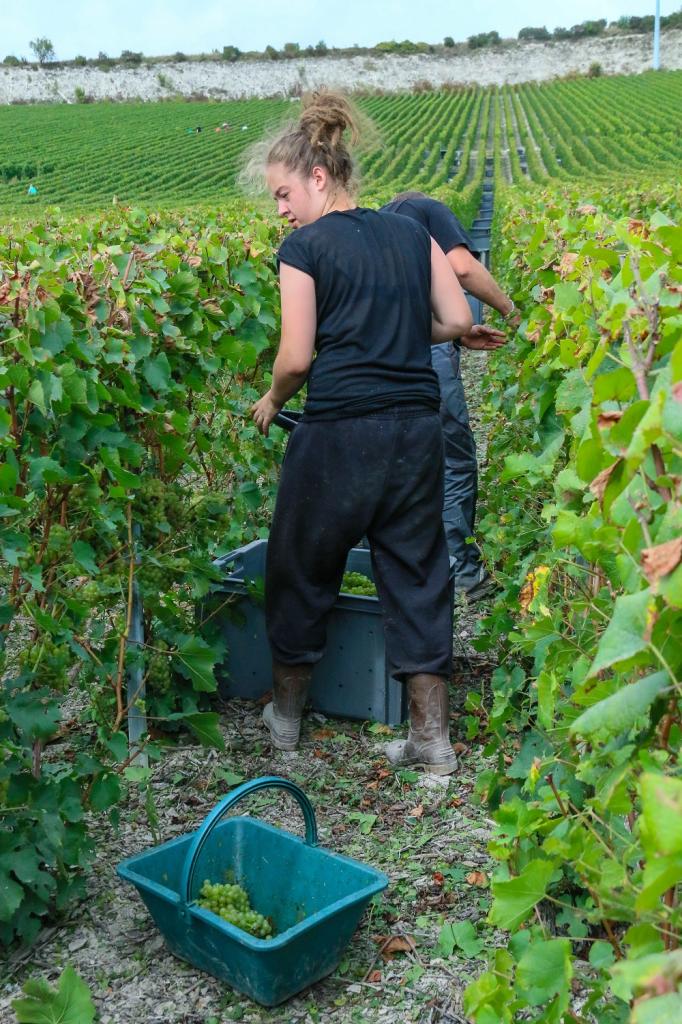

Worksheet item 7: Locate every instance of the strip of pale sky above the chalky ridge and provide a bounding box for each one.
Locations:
[0,0,680,60]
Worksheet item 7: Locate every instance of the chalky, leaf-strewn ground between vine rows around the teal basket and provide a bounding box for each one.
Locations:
[0,353,491,1024]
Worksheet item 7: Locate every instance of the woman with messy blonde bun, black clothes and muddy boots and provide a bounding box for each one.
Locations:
[253,93,471,774]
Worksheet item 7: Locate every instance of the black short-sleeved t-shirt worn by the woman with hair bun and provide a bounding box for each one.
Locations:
[279,207,439,419]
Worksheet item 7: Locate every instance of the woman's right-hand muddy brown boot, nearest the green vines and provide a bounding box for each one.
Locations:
[384,673,457,775]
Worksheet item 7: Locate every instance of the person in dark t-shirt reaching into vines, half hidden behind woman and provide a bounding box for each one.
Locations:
[382,191,518,601]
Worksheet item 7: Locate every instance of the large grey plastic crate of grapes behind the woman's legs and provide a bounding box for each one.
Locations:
[205,541,455,725]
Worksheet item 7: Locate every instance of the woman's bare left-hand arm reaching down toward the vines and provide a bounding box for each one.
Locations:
[251,263,317,434]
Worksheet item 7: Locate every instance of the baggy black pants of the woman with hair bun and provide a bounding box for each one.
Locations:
[265,409,453,679]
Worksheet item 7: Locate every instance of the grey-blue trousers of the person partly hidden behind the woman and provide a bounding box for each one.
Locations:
[431,342,481,590]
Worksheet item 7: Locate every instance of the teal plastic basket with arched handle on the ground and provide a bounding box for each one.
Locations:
[117,775,388,1007]
